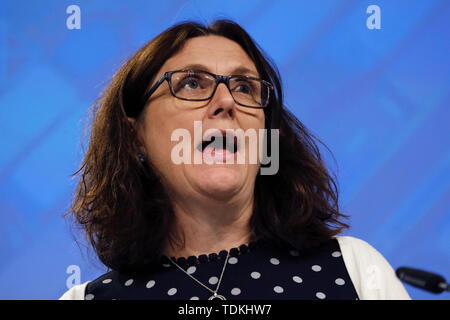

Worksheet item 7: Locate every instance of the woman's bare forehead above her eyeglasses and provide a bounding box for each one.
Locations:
[161,35,258,76]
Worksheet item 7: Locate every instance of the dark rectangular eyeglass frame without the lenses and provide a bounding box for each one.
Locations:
[144,69,273,109]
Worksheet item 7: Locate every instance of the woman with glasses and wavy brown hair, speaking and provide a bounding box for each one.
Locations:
[61,20,409,300]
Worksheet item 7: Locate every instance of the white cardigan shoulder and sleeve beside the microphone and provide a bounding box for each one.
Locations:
[336,236,411,300]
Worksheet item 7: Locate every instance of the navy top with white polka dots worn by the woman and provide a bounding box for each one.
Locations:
[85,239,358,300]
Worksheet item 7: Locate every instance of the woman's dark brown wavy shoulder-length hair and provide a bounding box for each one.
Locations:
[65,20,348,271]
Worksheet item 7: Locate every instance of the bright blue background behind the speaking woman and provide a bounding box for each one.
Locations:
[0,0,450,299]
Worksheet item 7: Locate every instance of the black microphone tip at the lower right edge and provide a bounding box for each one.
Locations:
[395,267,450,293]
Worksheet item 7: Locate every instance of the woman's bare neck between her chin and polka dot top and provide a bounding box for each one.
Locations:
[164,192,253,257]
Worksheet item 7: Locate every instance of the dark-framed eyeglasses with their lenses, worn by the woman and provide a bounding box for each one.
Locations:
[144,70,273,109]
